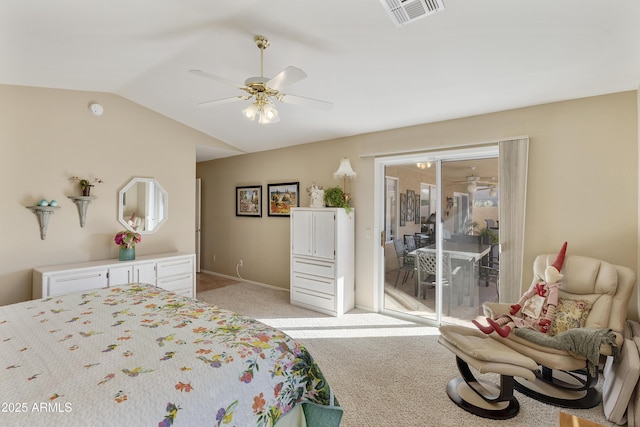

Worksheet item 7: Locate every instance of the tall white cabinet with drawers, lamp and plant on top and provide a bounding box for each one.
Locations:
[291,208,355,316]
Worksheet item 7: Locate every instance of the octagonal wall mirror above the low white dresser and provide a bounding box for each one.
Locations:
[118,178,169,234]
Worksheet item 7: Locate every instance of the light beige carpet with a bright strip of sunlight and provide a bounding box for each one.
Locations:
[197,283,615,427]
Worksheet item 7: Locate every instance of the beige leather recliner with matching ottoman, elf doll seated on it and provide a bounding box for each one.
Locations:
[439,254,635,419]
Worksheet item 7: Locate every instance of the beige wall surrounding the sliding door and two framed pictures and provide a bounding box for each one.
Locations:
[197,91,638,318]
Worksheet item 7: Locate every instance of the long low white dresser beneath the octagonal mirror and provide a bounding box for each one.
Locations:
[33,252,196,299]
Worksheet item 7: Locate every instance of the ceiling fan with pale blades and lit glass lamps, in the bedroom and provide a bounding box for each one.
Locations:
[189,36,333,124]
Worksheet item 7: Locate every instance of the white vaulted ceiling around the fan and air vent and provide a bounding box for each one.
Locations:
[0,0,640,160]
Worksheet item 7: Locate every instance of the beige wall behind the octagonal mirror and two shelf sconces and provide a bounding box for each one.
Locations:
[0,85,230,305]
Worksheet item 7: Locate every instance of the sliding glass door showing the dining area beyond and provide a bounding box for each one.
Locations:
[377,145,500,324]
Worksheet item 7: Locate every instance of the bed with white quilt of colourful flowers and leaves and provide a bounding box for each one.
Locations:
[0,284,342,426]
